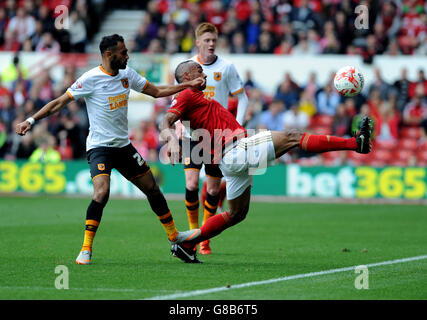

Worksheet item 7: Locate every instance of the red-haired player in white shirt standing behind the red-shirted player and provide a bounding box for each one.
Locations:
[184,22,248,254]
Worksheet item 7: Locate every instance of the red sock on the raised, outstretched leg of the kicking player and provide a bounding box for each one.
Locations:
[299,133,357,152]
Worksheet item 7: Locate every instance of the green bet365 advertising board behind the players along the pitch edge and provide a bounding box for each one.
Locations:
[0,161,427,200]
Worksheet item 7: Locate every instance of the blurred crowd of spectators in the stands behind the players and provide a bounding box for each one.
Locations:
[0,0,427,165]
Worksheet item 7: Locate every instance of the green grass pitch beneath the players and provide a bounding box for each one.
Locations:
[0,195,427,300]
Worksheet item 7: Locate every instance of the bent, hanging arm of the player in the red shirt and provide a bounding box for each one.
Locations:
[160,112,181,165]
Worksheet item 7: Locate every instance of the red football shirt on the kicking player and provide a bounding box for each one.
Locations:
[167,89,246,163]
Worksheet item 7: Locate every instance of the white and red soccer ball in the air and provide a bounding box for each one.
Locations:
[334,66,365,97]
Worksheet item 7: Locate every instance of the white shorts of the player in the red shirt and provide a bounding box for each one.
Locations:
[219,131,276,200]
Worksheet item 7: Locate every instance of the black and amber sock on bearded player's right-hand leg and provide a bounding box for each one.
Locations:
[147,190,178,241]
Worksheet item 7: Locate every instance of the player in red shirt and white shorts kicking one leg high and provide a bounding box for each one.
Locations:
[161,61,372,263]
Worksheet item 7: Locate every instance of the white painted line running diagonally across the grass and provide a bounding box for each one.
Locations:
[143,255,427,300]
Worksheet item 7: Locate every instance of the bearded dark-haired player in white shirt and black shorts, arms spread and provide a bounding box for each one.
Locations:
[16,34,205,264]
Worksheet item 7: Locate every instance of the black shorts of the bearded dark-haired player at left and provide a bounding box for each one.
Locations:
[87,143,150,180]
